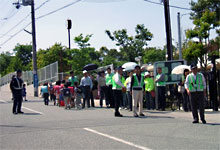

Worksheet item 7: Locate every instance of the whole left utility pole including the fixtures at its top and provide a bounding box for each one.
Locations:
[13,0,38,97]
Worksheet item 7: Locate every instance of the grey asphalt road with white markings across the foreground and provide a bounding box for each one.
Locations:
[0,91,220,150]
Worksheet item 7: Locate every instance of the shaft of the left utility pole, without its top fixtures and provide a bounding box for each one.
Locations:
[31,0,38,97]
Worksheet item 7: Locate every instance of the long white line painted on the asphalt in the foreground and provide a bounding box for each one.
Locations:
[84,128,151,150]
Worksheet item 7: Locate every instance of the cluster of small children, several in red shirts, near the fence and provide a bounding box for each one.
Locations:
[41,80,82,109]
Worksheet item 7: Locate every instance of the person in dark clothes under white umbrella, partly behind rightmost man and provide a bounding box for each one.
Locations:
[181,69,191,112]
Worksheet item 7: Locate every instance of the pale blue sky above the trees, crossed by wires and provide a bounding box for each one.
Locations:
[0,0,202,52]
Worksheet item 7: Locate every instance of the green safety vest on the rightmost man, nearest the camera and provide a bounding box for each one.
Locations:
[188,73,204,92]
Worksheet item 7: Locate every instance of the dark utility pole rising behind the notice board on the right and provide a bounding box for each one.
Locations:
[163,0,173,60]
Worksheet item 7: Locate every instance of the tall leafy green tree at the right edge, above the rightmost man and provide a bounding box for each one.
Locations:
[183,0,220,69]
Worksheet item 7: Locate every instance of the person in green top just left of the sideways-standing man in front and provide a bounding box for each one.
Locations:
[105,67,115,108]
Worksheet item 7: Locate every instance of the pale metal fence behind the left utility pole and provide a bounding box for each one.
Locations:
[0,62,58,86]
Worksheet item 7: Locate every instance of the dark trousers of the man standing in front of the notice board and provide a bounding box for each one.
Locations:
[157,86,166,110]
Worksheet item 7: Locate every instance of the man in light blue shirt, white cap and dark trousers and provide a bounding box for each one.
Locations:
[80,70,93,108]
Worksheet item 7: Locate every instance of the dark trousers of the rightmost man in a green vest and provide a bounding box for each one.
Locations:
[190,92,205,121]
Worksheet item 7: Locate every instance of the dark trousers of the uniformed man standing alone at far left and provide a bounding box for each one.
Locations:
[12,91,22,113]
